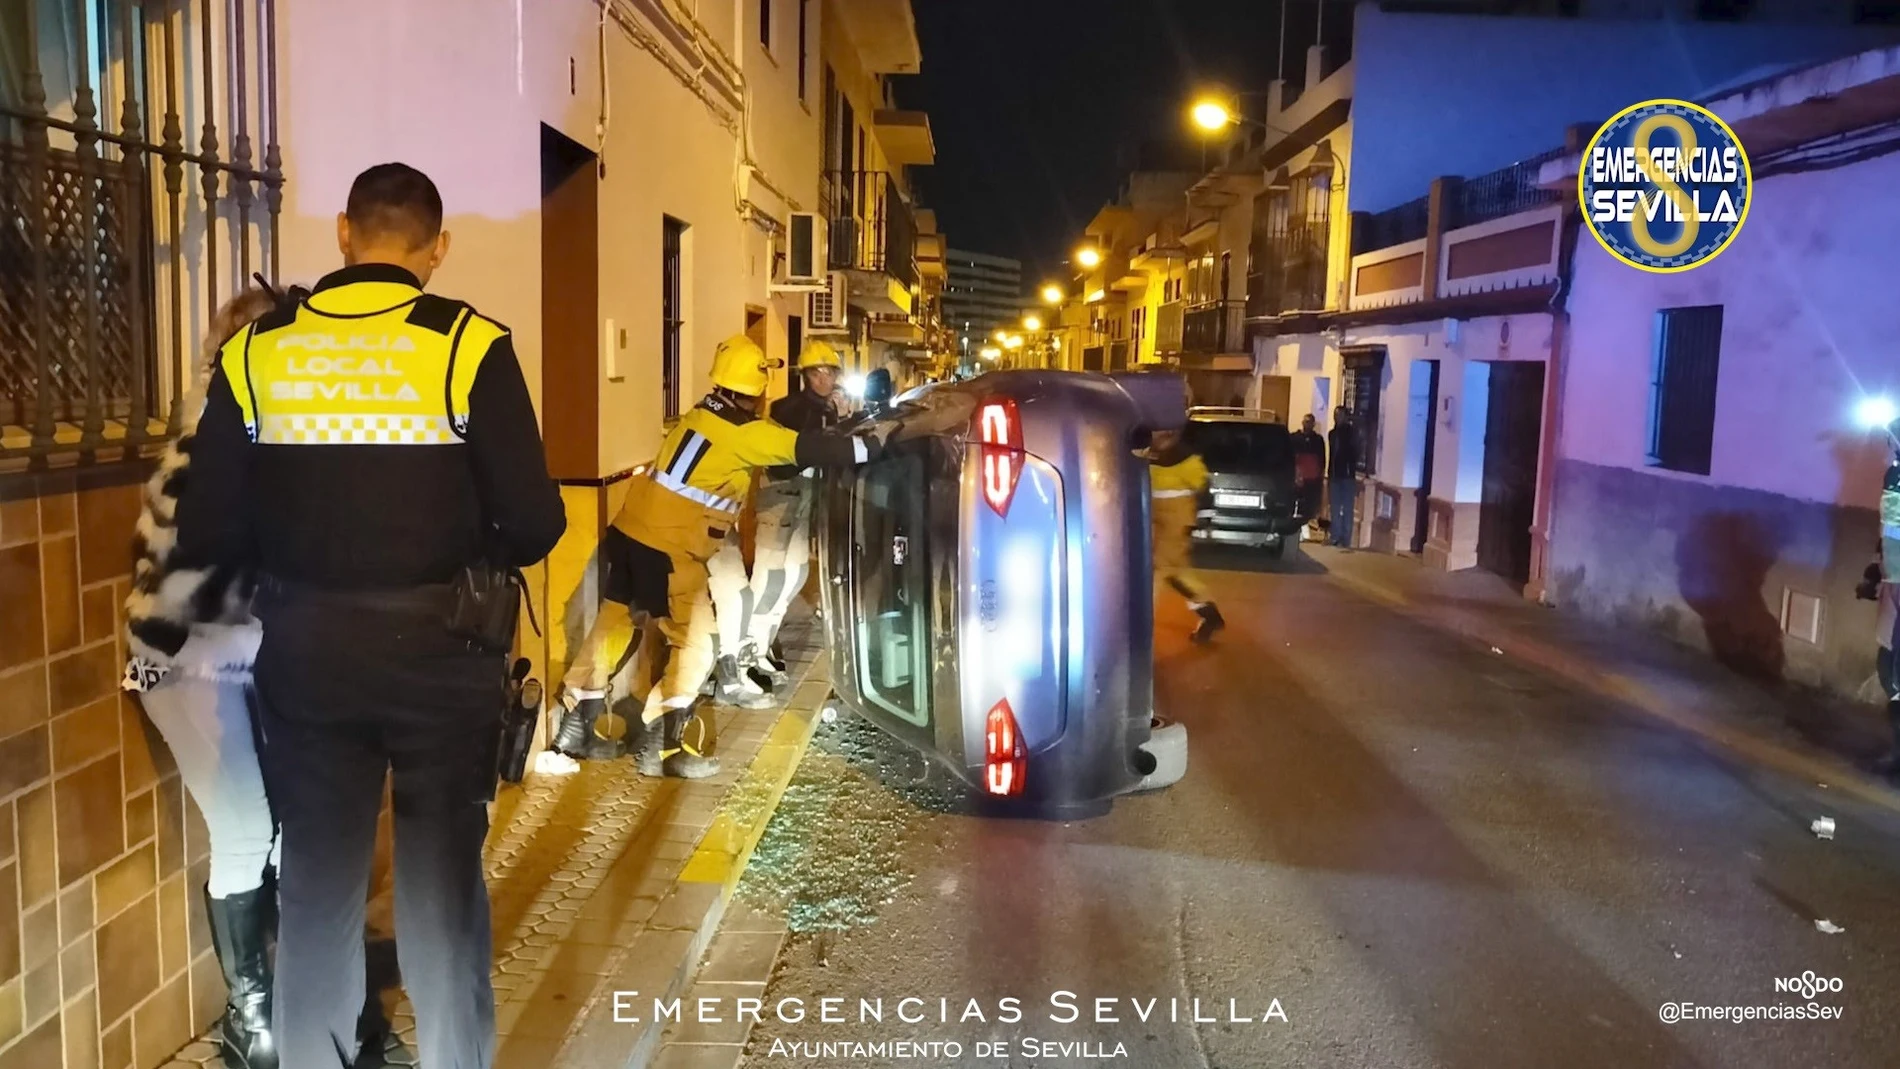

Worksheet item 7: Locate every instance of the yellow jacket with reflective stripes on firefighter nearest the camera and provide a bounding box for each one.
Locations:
[614,395,798,560]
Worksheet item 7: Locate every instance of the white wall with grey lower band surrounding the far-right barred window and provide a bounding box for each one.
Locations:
[1550,144,1900,693]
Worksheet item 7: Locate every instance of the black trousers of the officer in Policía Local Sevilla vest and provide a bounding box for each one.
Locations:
[258,592,502,1069]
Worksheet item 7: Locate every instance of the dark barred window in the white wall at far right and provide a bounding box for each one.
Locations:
[1649,304,1721,475]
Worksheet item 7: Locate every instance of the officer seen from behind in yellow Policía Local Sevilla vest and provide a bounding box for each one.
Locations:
[177,163,566,1069]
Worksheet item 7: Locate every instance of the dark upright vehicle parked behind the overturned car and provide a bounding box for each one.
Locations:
[1188,408,1311,556]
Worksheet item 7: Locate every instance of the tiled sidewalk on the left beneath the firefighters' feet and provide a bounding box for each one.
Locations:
[163,611,830,1069]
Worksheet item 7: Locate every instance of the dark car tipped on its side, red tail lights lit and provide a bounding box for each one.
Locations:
[813,370,1188,818]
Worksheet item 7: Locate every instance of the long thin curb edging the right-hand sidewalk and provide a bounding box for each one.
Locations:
[1328,570,1900,813]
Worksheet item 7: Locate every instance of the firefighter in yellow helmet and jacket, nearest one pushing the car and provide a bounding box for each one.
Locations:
[555,334,887,778]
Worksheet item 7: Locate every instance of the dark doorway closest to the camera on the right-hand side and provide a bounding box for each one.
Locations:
[1478,361,1545,587]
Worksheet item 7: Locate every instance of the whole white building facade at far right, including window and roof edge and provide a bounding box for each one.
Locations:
[1549,47,1900,697]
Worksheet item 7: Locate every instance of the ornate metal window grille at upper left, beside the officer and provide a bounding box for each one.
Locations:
[0,0,283,467]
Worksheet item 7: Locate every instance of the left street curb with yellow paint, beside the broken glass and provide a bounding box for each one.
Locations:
[559,651,830,1069]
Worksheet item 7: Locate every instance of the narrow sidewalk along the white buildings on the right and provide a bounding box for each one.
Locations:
[1303,545,1900,813]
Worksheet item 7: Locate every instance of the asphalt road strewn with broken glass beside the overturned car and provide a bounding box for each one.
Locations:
[722,566,1900,1069]
